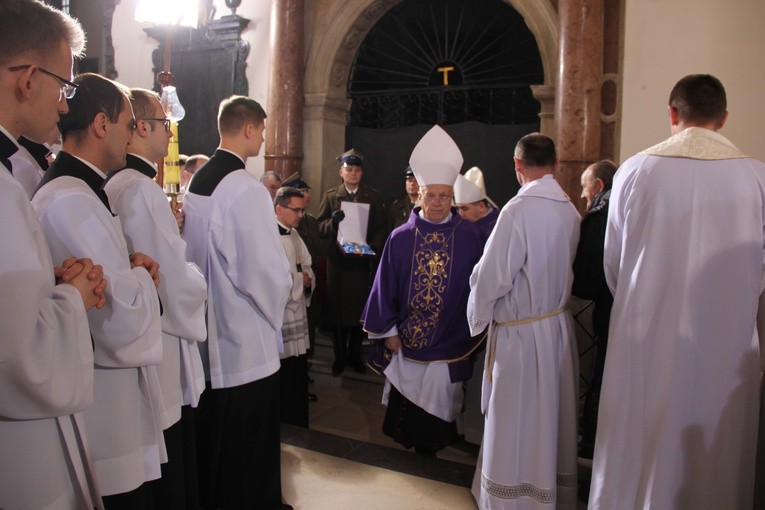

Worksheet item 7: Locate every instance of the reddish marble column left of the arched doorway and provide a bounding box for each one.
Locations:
[265,0,305,178]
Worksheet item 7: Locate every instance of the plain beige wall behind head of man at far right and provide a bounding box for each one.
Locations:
[620,0,765,161]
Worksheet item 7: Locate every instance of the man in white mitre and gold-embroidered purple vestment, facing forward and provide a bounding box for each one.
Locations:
[362,126,481,456]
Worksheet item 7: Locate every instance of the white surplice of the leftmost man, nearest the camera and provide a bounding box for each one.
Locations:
[0,161,103,510]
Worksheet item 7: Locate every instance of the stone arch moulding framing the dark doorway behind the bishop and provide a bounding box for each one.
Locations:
[303,0,558,197]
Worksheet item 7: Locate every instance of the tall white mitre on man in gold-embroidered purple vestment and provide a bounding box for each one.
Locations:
[409,126,464,186]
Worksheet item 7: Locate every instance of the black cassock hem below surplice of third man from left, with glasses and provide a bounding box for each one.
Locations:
[149,406,200,510]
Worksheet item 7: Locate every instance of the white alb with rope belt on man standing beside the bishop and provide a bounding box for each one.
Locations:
[467,175,580,509]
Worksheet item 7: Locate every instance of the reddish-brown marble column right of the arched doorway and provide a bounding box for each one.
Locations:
[555,0,603,211]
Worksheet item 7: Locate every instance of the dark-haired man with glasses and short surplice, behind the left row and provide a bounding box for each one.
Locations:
[274,187,316,427]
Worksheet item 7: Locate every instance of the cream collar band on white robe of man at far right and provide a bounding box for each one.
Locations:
[640,127,749,161]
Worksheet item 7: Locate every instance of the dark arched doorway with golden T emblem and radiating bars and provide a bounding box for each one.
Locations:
[345,0,543,204]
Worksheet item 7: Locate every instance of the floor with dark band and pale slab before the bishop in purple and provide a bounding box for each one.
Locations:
[282,373,585,510]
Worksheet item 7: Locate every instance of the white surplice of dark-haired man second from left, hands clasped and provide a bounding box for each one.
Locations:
[32,162,166,495]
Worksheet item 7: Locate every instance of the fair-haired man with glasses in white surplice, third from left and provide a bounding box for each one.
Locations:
[104,88,207,508]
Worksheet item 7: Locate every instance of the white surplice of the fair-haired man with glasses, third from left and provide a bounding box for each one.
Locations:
[104,156,207,422]
